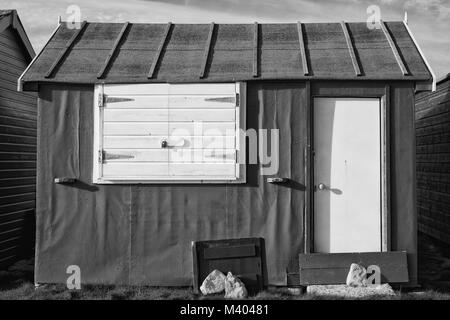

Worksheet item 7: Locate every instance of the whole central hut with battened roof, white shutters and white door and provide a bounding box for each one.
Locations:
[19,22,433,286]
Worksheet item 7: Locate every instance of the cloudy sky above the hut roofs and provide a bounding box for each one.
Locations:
[0,0,450,78]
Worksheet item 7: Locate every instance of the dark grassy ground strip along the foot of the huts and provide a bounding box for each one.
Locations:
[0,235,450,300]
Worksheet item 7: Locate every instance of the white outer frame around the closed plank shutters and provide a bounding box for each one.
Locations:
[92,82,247,184]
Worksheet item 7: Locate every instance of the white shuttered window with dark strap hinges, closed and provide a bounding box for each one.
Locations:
[93,83,245,183]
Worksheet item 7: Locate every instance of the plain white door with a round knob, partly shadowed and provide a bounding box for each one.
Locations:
[313,98,381,253]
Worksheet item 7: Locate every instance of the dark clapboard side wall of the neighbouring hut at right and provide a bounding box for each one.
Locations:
[416,74,450,244]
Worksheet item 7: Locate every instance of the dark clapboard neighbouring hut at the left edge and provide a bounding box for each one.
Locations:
[0,10,37,268]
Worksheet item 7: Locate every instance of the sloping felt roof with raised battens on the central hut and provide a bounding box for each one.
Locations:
[22,22,432,83]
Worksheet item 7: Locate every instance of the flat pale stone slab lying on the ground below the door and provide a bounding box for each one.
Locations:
[306,283,395,299]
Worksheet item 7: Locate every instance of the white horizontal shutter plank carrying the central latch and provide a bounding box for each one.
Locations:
[103,136,236,149]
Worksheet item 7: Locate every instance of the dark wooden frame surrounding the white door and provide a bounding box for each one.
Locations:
[304,81,391,253]
